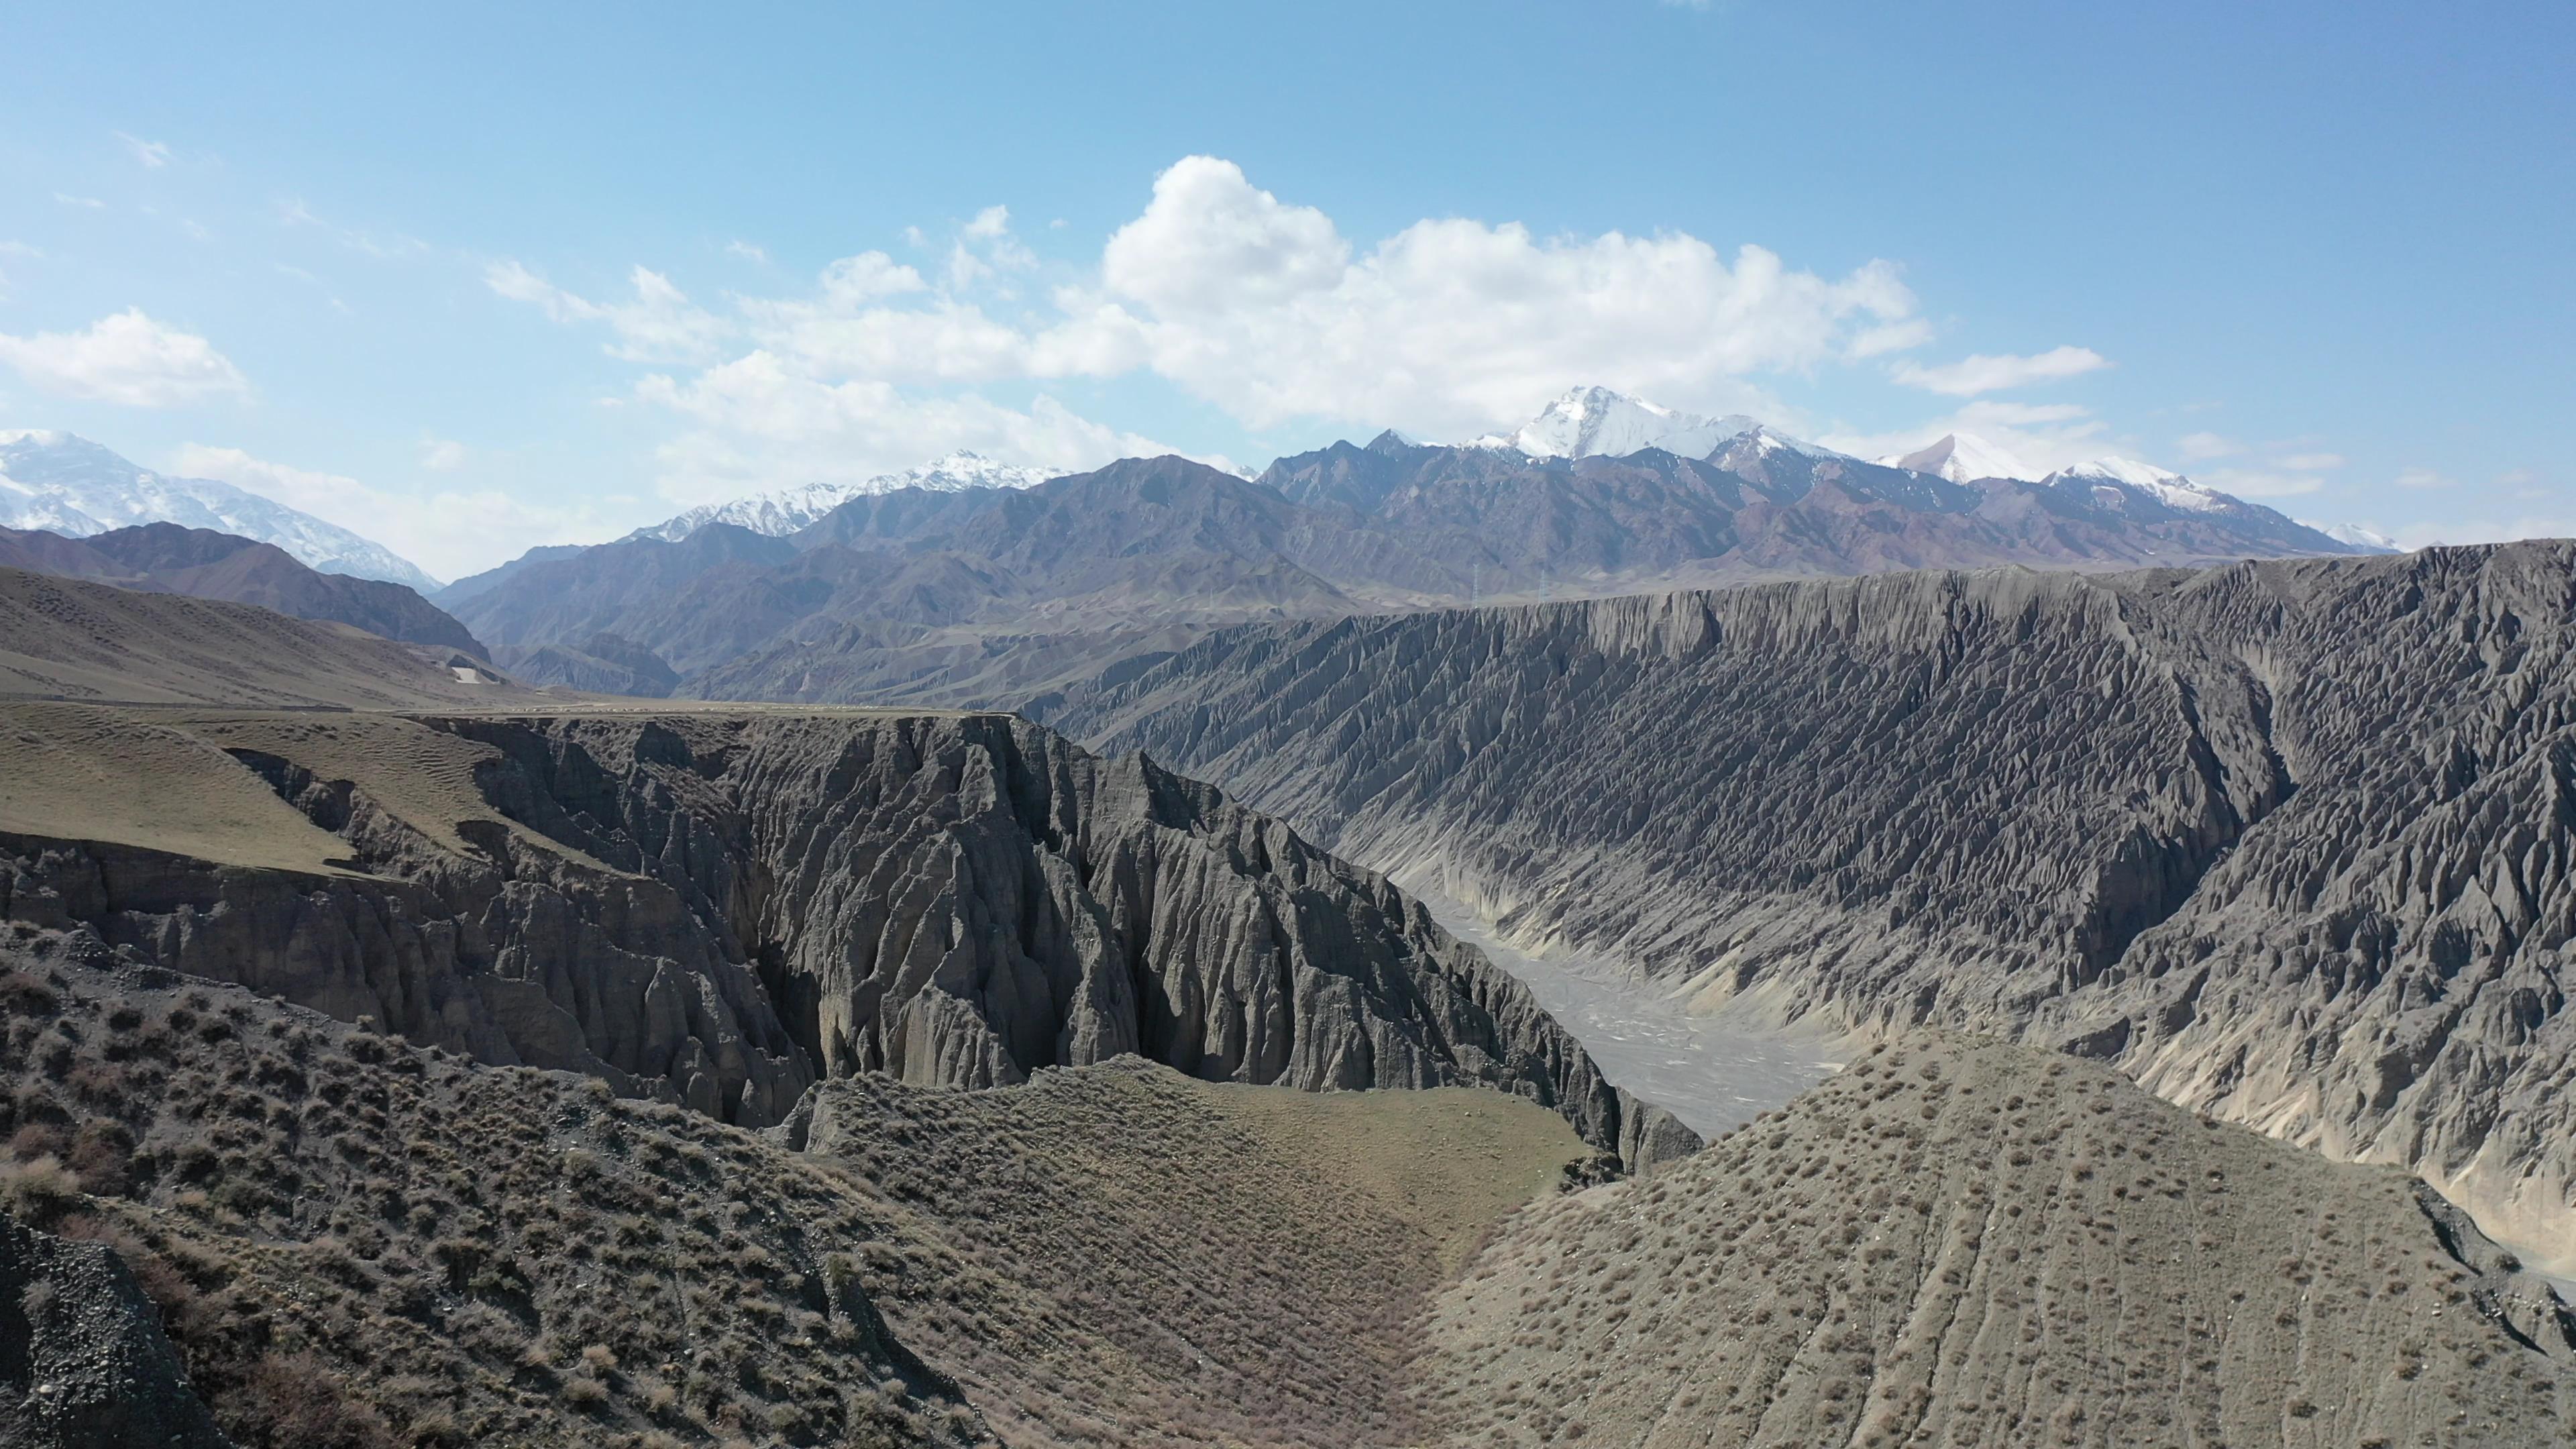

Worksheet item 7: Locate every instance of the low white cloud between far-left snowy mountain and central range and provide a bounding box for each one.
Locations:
[170,443,612,578]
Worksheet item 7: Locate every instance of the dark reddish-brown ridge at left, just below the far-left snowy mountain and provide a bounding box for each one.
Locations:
[0,523,490,660]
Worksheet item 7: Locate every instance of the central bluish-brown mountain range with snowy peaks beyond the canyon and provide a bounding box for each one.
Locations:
[438,389,2362,706]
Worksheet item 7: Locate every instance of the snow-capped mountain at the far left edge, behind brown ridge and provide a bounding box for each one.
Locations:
[0,428,438,593]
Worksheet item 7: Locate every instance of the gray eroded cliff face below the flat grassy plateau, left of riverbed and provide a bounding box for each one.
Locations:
[0,714,1695,1165]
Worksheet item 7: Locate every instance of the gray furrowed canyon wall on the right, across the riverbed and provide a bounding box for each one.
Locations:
[1051,544,2576,1263]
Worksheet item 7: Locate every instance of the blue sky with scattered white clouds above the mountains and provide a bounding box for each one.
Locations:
[0,0,2576,575]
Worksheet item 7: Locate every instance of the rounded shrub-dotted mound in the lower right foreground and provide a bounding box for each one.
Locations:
[1419,1034,2576,1449]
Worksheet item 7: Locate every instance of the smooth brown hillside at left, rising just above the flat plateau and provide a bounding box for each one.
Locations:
[0,568,543,709]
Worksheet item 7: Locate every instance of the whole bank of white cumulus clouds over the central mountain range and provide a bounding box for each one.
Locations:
[484,157,1978,498]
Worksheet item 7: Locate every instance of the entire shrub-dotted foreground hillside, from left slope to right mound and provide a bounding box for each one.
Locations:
[0,928,2576,1449]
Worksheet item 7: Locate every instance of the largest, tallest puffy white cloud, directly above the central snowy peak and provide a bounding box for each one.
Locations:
[1066,157,1914,436]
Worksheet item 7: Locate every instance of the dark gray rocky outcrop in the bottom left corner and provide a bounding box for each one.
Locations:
[0,1212,232,1449]
